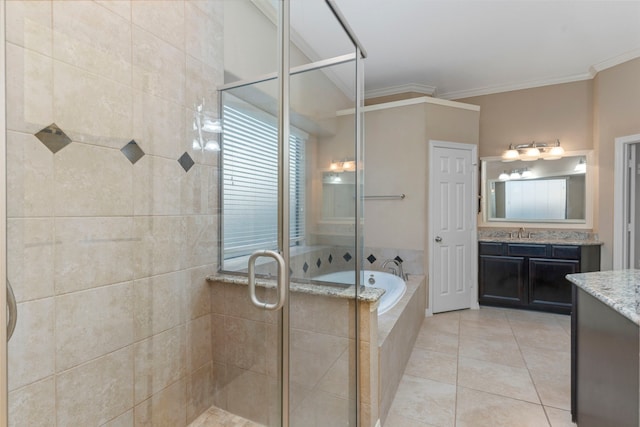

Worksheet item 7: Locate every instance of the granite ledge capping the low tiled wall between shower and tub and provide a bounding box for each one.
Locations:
[207,274,384,303]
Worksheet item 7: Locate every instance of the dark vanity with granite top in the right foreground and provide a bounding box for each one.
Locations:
[568,270,640,427]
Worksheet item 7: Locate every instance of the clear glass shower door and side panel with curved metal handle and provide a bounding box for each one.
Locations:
[214,0,362,427]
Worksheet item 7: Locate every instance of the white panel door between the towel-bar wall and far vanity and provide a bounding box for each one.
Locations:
[429,142,477,313]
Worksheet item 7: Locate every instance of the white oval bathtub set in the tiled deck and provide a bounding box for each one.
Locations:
[313,270,407,316]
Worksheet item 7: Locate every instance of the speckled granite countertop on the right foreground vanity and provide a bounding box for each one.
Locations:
[567,270,640,326]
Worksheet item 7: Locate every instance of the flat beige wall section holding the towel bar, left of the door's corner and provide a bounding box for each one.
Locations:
[364,104,427,249]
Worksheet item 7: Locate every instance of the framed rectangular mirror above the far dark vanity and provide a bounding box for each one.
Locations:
[481,152,590,224]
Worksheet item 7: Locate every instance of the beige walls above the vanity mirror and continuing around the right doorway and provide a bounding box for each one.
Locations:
[460,59,640,270]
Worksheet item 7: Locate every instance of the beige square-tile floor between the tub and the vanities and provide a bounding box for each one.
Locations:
[384,307,575,427]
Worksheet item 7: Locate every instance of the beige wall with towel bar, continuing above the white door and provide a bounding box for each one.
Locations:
[364,103,479,271]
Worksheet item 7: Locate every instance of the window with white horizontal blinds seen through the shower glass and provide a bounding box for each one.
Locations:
[222,105,306,260]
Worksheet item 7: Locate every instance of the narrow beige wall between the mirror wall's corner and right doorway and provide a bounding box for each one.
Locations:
[594,59,640,270]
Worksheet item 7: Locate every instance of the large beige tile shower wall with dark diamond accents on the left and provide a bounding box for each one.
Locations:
[6,0,223,427]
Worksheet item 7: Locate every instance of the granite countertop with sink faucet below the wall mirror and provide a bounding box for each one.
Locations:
[478,227,601,245]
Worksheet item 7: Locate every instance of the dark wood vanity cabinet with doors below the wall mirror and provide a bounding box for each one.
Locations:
[478,242,600,313]
